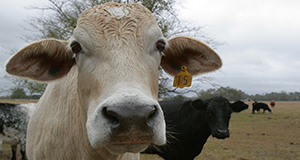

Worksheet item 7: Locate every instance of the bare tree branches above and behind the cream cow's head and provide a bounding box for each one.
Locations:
[26,0,216,40]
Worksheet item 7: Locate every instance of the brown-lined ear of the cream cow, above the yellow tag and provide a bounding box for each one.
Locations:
[161,37,222,76]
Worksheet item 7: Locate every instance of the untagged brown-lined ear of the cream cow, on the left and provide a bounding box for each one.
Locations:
[6,39,75,81]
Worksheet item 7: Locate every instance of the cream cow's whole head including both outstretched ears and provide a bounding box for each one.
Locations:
[6,3,222,153]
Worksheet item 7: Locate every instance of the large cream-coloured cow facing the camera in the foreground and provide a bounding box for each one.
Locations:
[6,2,222,160]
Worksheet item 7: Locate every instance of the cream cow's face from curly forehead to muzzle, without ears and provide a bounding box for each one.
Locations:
[69,3,167,152]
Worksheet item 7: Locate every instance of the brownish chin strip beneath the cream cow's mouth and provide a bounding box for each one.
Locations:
[105,143,150,154]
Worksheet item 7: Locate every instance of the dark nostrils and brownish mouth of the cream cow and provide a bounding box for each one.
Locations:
[102,105,158,144]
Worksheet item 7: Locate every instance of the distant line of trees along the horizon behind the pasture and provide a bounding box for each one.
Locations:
[0,82,300,101]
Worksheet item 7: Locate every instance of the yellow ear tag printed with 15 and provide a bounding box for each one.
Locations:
[173,66,193,88]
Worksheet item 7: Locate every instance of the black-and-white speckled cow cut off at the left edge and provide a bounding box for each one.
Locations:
[0,103,36,160]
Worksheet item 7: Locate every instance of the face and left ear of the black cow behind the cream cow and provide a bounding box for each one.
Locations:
[192,96,232,139]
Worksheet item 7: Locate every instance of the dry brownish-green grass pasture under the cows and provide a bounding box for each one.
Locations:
[0,101,300,160]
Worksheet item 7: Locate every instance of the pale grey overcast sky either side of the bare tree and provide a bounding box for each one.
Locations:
[0,0,300,94]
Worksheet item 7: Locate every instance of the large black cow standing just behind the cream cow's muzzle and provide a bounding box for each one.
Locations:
[143,97,232,160]
